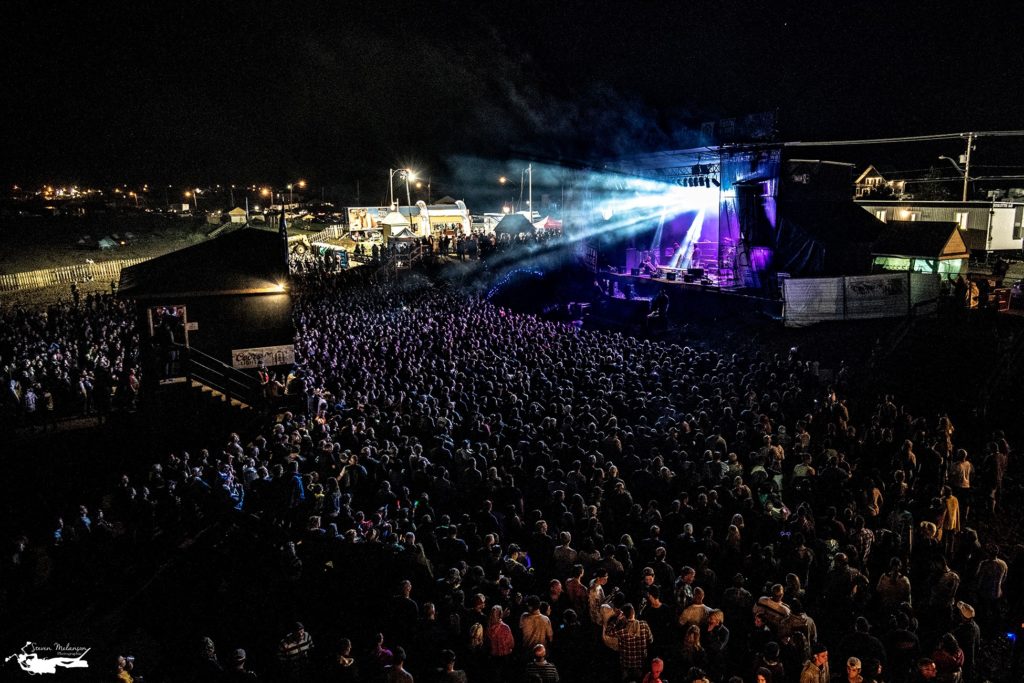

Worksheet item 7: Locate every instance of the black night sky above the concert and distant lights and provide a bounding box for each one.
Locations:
[0,0,1024,194]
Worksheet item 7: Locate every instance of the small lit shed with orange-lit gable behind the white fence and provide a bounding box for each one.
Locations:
[871,220,971,275]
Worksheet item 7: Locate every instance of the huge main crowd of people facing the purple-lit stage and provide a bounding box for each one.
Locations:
[4,272,1024,683]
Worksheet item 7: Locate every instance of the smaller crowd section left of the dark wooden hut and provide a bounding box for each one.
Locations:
[0,288,139,430]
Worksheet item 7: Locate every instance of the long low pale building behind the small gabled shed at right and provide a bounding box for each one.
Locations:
[857,199,1024,255]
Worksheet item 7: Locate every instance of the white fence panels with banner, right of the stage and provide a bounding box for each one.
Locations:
[782,272,939,328]
